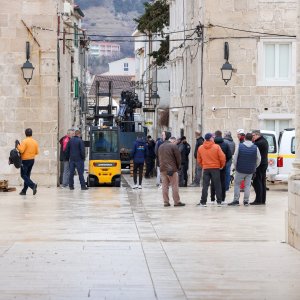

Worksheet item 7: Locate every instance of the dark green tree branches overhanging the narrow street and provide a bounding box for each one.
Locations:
[134,0,170,66]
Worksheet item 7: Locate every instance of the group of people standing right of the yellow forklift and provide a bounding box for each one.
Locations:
[132,129,269,206]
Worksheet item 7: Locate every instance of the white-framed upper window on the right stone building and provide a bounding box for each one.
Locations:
[258,39,296,86]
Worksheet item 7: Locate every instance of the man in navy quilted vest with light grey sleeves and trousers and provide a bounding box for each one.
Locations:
[228,133,261,206]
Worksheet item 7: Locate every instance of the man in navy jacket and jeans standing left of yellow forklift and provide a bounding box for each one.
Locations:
[67,130,88,190]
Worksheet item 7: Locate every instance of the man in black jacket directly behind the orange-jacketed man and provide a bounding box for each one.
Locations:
[211,130,232,201]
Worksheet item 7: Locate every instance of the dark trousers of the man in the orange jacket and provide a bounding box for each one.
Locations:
[200,169,222,204]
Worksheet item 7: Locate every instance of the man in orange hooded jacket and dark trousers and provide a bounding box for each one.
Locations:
[197,133,226,206]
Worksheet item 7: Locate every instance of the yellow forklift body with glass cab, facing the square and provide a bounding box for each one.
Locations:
[88,126,121,187]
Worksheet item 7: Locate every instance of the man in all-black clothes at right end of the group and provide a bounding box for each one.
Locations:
[250,130,269,205]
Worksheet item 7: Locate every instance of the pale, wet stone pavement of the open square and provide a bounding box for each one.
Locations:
[0,175,300,300]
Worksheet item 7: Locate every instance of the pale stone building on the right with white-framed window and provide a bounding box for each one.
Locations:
[170,0,297,141]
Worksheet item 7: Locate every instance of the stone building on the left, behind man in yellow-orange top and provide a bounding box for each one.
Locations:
[0,0,86,185]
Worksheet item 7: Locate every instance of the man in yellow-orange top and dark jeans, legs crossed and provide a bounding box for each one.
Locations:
[15,128,39,195]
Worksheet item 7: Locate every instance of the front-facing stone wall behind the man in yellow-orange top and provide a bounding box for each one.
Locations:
[0,0,58,185]
